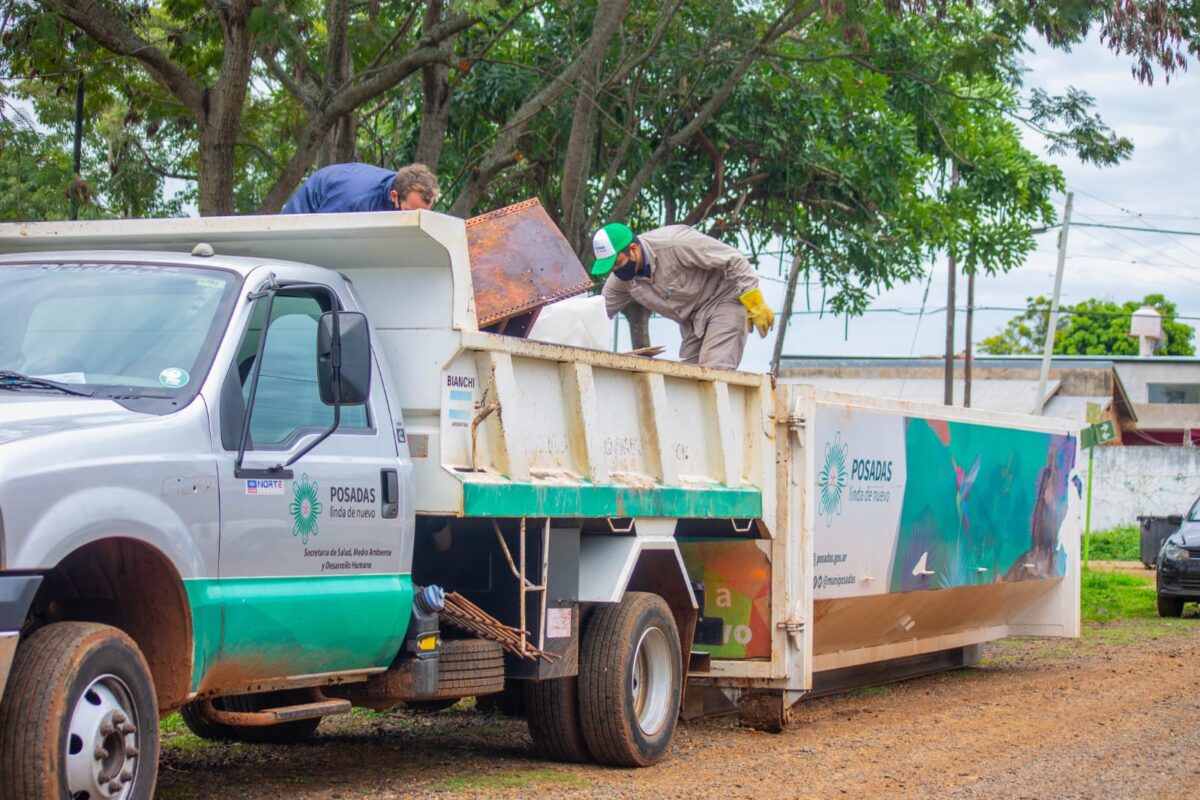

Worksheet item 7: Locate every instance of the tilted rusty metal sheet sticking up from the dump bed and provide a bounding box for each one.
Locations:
[467,199,592,336]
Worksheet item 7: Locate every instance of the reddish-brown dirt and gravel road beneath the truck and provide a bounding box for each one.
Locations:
[158,607,1200,800]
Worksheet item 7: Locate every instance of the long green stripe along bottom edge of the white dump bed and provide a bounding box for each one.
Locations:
[462,481,762,519]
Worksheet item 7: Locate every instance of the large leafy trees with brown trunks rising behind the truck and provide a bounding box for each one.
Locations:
[0,0,1198,347]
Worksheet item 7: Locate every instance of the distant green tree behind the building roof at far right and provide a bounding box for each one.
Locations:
[979,294,1195,355]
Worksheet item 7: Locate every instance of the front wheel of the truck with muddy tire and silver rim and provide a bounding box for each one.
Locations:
[0,622,158,800]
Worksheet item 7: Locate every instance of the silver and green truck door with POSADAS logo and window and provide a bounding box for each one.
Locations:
[206,283,413,688]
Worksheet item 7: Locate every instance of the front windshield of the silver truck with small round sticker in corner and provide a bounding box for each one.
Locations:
[0,263,238,397]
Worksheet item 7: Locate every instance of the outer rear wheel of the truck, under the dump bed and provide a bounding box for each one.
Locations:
[578,591,683,766]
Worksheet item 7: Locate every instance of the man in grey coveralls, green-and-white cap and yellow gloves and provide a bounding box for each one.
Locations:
[592,222,775,369]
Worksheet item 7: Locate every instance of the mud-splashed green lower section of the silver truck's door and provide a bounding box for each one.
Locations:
[184,575,413,691]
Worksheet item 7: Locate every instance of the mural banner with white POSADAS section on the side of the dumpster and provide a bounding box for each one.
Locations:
[814,407,1076,599]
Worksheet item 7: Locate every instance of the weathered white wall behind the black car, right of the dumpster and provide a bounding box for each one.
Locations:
[1079,447,1200,530]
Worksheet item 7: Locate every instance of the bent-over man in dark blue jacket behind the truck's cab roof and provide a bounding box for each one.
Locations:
[283,163,438,213]
